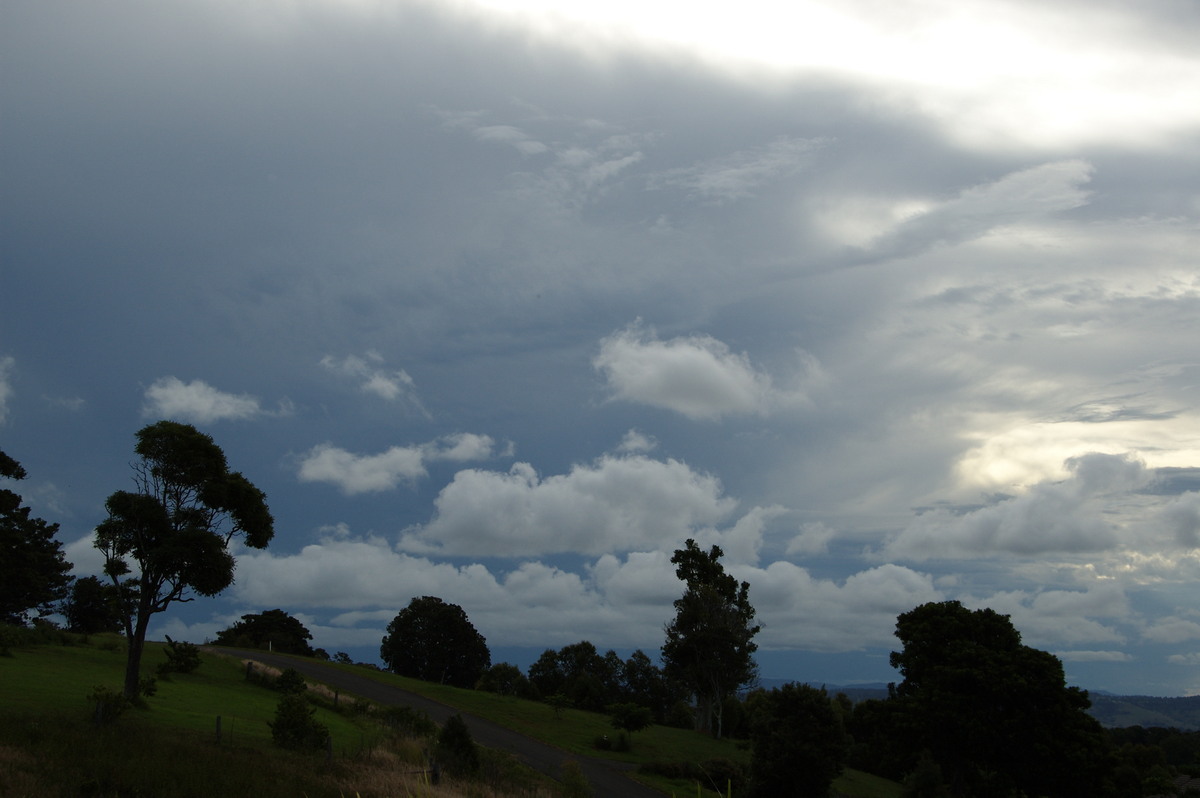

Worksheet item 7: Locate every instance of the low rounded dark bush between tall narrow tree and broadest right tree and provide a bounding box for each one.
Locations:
[746,684,848,798]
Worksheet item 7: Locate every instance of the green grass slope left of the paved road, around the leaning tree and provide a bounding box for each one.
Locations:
[0,629,475,798]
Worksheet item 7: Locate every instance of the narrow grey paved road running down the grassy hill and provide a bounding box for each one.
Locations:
[213,647,662,798]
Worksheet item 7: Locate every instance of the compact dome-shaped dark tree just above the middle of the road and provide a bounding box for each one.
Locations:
[379,595,492,688]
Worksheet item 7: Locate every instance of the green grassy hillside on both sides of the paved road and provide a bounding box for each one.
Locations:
[0,632,899,798]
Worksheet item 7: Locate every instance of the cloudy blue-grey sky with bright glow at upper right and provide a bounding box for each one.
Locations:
[0,0,1200,695]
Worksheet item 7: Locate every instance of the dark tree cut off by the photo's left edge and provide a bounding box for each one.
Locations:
[0,451,72,626]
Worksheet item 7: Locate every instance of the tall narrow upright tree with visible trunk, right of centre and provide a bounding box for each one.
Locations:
[662,540,760,737]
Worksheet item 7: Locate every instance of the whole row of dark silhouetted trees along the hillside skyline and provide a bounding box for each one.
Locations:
[0,421,1171,798]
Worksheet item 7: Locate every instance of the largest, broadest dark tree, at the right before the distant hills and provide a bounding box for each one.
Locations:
[890,601,1111,797]
